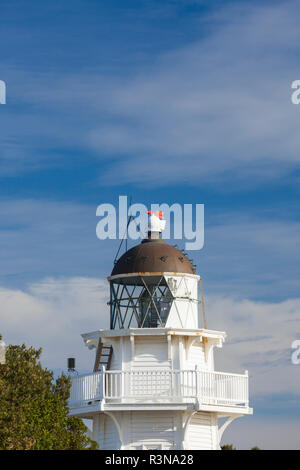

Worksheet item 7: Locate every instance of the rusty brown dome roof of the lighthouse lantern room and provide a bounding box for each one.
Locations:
[111,238,195,276]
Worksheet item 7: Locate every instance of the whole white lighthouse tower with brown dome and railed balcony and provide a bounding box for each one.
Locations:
[69,213,252,450]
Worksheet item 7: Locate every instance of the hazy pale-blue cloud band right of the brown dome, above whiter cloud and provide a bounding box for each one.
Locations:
[199,214,300,301]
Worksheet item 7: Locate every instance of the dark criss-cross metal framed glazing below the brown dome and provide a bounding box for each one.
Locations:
[109,274,174,330]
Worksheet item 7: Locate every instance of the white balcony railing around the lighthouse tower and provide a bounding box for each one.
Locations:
[69,370,248,408]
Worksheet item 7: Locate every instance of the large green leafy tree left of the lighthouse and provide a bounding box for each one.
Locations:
[0,338,97,450]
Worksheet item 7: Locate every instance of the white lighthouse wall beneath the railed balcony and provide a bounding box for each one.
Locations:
[93,410,218,450]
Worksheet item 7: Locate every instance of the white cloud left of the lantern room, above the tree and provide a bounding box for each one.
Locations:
[0,277,109,370]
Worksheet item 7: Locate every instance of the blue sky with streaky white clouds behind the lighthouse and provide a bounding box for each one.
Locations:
[0,0,300,448]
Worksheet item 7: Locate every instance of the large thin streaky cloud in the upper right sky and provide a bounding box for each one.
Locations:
[74,2,300,185]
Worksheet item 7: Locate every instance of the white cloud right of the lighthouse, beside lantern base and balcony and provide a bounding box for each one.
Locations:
[206,297,300,396]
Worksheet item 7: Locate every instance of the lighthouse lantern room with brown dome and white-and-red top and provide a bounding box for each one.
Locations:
[108,212,200,329]
